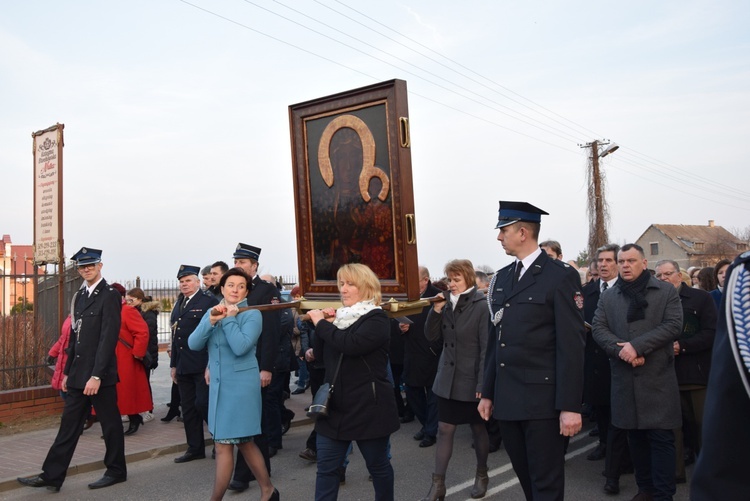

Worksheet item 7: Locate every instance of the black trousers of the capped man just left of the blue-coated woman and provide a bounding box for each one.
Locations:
[177,372,208,454]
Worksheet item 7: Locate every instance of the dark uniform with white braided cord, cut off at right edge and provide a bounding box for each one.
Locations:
[690,252,750,501]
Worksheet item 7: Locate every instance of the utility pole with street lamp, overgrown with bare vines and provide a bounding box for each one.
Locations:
[579,140,619,259]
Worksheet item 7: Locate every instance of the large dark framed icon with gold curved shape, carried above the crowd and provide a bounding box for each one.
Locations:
[289,80,419,301]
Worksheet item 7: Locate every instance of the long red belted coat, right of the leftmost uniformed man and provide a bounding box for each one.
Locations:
[115,304,154,415]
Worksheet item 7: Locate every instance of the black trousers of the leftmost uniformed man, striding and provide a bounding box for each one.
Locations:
[41,385,128,487]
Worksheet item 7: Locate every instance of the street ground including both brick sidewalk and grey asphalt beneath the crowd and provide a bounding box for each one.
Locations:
[0,353,692,501]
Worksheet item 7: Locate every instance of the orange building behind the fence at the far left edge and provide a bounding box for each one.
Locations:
[0,235,37,315]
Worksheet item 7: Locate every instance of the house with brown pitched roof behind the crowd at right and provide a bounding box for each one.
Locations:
[636,219,747,269]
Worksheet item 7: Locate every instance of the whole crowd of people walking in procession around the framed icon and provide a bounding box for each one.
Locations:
[19,198,746,501]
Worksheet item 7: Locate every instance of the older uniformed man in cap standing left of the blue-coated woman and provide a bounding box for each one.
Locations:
[169,264,219,463]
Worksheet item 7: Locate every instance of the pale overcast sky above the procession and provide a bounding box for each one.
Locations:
[0,0,750,281]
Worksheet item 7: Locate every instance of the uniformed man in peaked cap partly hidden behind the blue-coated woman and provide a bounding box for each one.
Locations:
[229,242,285,492]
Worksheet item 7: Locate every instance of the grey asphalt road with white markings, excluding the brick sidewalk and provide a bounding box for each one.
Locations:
[3,422,692,501]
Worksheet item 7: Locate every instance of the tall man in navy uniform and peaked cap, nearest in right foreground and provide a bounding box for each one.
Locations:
[479,201,585,501]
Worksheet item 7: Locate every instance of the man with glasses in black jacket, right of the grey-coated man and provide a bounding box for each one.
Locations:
[655,260,716,483]
